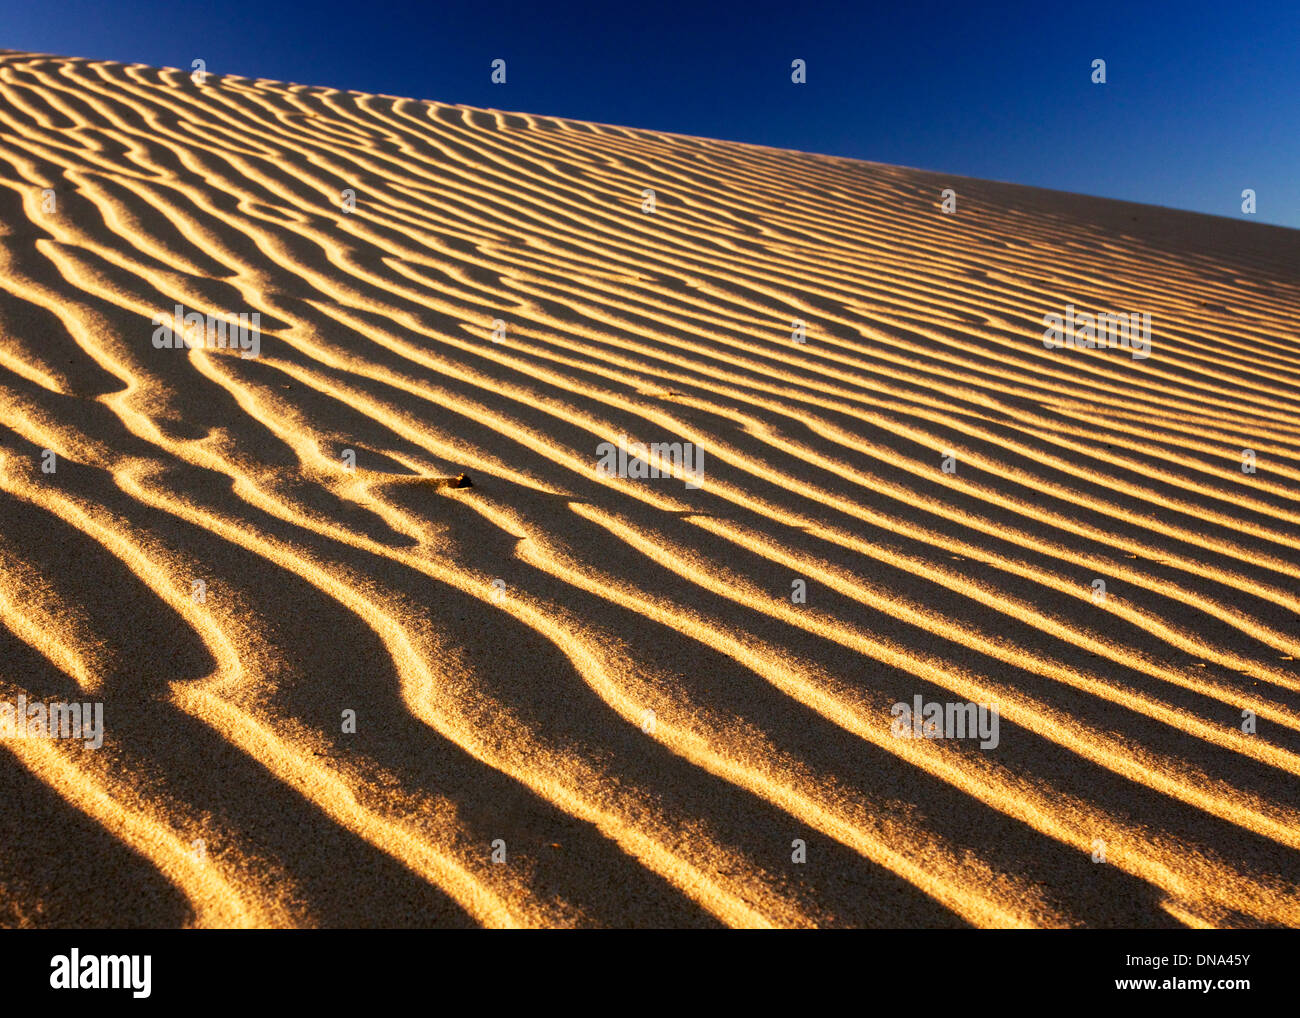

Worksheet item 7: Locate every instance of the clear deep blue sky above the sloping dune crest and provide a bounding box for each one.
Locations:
[0,0,1300,226]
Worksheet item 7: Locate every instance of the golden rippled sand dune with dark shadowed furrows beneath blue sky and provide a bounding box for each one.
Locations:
[0,51,1300,927]
